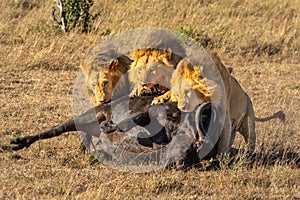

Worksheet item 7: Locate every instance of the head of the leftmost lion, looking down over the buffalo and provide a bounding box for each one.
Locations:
[80,52,132,106]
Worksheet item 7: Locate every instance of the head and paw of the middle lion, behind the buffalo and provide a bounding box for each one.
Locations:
[128,48,181,97]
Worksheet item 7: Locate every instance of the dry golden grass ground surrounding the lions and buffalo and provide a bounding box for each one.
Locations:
[0,0,300,199]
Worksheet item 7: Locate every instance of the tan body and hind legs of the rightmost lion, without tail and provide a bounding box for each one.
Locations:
[211,54,256,153]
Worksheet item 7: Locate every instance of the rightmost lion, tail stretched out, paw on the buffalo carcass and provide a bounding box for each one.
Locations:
[152,53,285,154]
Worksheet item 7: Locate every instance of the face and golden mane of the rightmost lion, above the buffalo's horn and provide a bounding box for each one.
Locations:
[171,60,211,112]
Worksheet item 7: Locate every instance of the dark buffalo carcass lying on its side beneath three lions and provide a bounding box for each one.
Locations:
[10,96,215,169]
